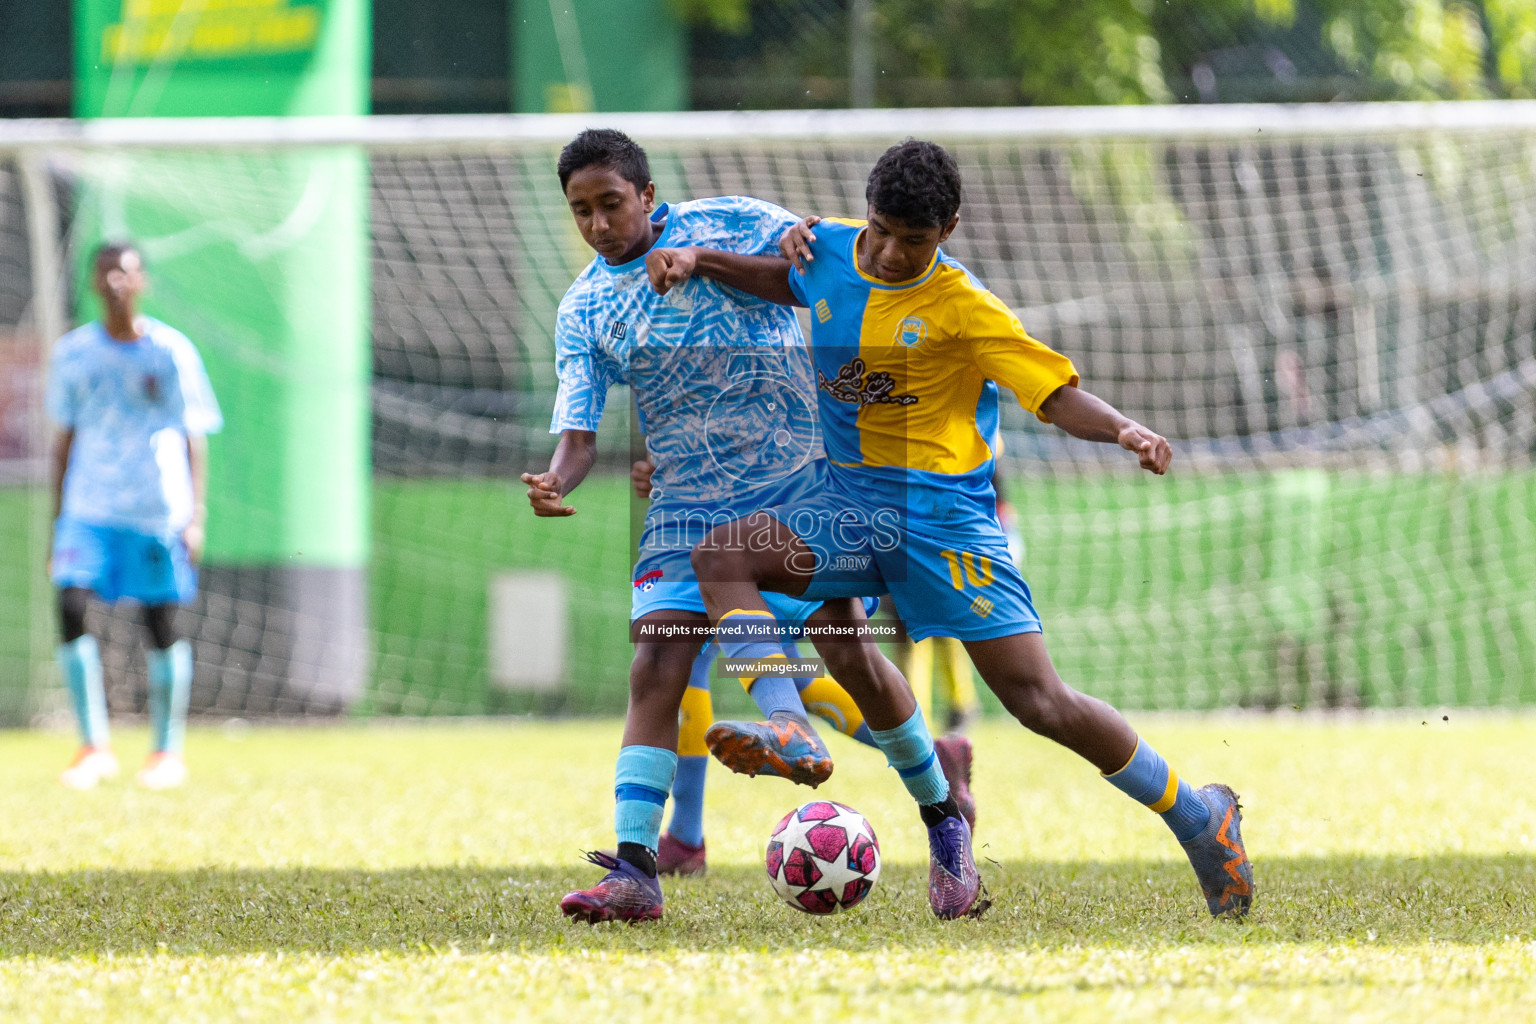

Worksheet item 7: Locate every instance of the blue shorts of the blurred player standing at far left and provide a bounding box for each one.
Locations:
[52,516,197,605]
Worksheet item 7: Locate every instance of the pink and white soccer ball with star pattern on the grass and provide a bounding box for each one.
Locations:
[768,800,880,913]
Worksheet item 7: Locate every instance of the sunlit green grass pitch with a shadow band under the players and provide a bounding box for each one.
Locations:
[0,711,1536,1024]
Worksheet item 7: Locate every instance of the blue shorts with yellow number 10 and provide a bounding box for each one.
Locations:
[766,473,1041,640]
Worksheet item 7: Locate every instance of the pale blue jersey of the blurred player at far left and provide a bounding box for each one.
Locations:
[46,316,224,533]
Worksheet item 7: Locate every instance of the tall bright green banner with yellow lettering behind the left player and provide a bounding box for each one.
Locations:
[71,0,370,706]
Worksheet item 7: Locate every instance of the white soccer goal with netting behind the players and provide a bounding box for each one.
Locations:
[0,103,1536,720]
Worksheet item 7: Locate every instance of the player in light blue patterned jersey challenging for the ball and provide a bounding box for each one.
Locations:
[522,129,948,923]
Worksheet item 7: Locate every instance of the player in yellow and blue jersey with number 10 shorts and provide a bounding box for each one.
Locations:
[650,140,1253,917]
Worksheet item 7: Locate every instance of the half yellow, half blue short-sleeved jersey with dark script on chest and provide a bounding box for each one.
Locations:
[790,220,1078,494]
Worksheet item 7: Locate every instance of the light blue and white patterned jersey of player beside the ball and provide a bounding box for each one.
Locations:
[550,197,823,513]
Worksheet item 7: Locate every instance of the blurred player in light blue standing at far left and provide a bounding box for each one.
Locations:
[46,244,224,789]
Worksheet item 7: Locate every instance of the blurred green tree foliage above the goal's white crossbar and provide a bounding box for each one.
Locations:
[673,0,1536,107]
